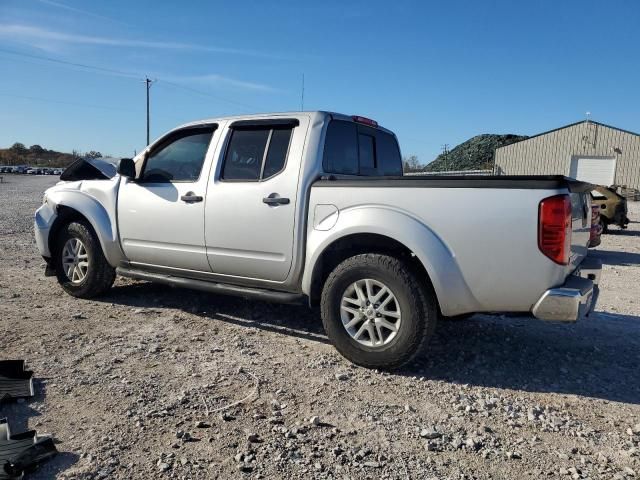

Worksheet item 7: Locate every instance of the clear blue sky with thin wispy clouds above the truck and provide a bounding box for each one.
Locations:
[0,0,640,163]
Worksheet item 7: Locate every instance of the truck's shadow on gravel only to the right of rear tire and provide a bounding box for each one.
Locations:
[416,312,640,404]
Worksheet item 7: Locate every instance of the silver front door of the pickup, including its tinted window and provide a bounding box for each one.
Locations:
[118,126,215,272]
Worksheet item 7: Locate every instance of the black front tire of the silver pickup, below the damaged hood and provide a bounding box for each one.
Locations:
[54,221,116,298]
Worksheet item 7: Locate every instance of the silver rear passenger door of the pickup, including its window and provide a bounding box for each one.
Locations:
[205,117,309,282]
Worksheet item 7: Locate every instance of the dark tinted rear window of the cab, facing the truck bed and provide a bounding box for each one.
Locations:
[323,120,402,175]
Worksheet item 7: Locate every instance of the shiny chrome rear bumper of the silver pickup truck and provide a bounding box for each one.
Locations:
[531,258,602,322]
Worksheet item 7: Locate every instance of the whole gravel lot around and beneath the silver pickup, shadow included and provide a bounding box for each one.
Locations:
[0,176,640,479]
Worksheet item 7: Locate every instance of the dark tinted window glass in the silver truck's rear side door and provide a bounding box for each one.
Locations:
[221,127,292,181]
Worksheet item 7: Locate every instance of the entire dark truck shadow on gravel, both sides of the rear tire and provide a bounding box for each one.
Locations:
[102,282,640,404]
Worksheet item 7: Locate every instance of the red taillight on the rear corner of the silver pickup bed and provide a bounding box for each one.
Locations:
[538,195,571,265]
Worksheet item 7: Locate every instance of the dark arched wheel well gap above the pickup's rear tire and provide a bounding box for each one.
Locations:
[309,233,433,306]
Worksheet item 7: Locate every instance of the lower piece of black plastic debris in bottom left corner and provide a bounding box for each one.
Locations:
[0,418,58,480]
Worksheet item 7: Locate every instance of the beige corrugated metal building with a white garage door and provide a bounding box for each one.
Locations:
[494,120,640,191]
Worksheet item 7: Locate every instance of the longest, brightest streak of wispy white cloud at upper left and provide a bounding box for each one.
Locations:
[0,24,286,58]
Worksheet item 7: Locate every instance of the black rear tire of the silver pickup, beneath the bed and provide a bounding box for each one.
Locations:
[320,253,438,370]
